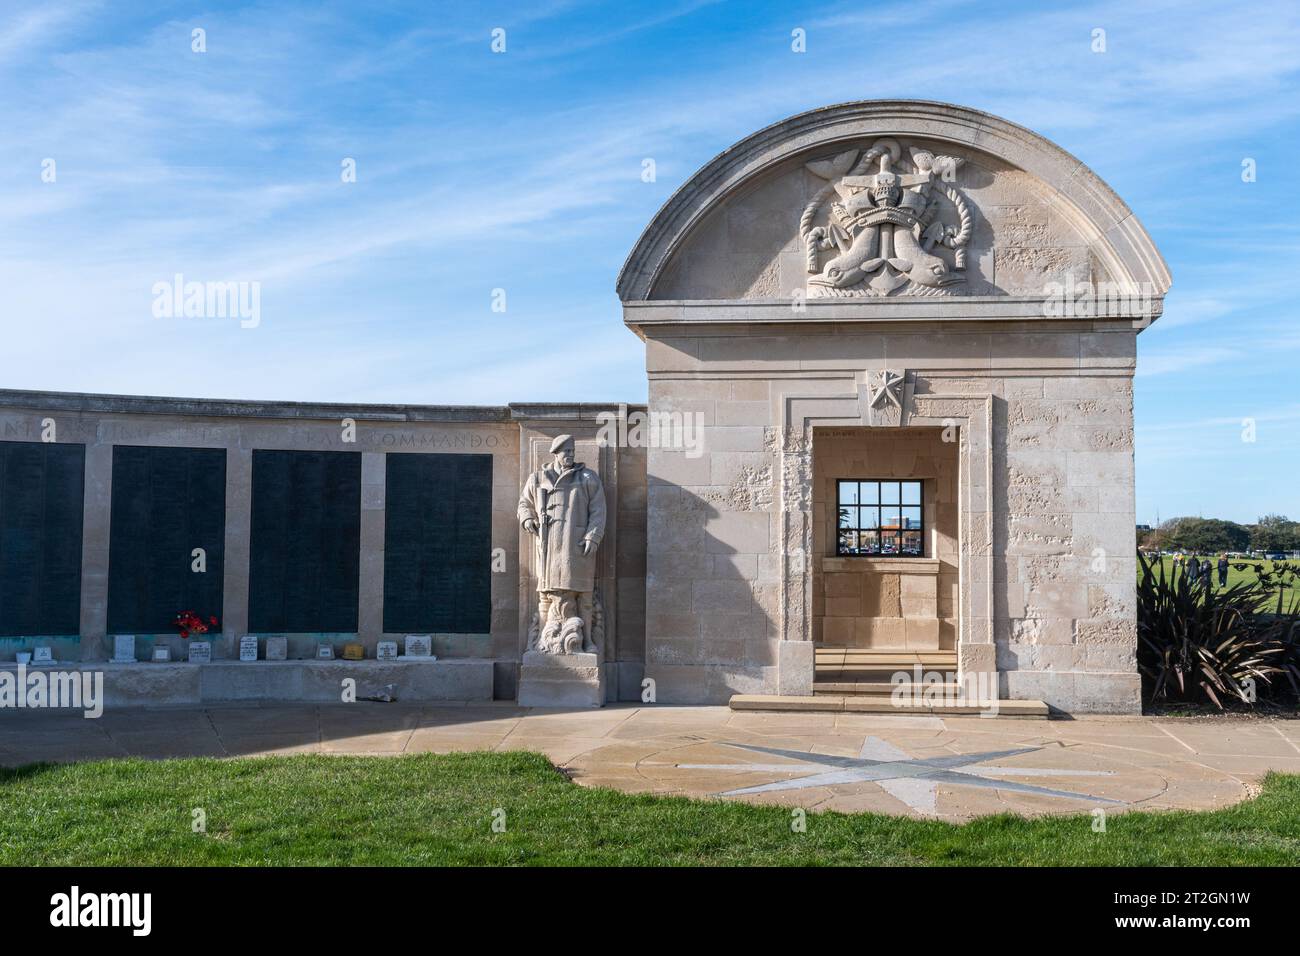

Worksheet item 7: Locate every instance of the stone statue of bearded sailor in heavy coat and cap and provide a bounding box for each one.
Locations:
[519,434,605,654]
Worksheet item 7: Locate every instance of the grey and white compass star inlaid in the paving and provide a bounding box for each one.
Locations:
[677,736,1123,814]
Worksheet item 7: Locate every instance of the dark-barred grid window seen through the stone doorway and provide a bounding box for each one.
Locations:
[835,479,926,558]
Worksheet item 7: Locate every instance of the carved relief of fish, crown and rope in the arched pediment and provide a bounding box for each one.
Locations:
[800,139,971,298]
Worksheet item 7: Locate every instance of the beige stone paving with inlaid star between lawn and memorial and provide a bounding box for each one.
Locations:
[0,704,1300,821]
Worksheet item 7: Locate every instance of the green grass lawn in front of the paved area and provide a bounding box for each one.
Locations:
[0,752,1300,866]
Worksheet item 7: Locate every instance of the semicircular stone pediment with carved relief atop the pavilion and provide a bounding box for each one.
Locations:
[618,100,1170,311]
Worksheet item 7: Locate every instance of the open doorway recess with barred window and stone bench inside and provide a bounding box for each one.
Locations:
[813,427,959,650]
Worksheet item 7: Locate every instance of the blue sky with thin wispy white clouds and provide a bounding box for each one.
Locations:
[0,0,1300,522]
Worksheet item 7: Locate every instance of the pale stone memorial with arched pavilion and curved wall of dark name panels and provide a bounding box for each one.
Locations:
[0,100,1170,713]
